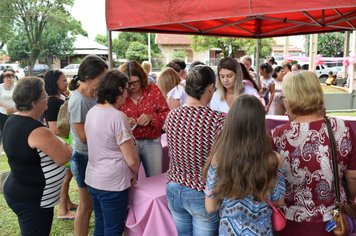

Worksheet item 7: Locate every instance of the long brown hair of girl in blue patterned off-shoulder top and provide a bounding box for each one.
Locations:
[203,94,278,202]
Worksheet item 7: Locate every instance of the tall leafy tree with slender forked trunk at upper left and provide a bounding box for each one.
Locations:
[2,0,73,75]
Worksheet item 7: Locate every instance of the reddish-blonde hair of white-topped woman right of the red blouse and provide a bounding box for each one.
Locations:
[157,67,180,100]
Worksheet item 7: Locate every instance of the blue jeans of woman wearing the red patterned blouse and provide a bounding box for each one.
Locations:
[135,137,163,177]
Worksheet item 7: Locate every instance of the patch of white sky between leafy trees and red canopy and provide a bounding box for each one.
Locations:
[71,0,106,40]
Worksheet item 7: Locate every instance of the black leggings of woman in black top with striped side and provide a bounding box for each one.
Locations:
[4,194,54,236]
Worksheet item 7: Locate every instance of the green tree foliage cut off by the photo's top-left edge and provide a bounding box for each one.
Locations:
[0,1,15,49]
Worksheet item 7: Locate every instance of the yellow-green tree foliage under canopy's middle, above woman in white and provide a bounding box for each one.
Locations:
[188,35,247,58]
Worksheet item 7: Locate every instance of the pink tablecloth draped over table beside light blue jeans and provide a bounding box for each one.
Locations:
[125,173,178,236]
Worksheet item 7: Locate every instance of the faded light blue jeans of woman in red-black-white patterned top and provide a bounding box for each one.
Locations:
[166,182,220,236]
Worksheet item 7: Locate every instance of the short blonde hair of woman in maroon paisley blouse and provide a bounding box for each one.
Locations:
[282,71,324,115]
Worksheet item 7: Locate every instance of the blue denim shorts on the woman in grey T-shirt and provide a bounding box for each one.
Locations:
[70,151,88,188]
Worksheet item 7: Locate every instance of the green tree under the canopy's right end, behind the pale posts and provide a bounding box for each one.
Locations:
[306,32,345,57]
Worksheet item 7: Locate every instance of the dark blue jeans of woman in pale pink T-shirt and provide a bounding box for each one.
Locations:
[88,186,129,236]
